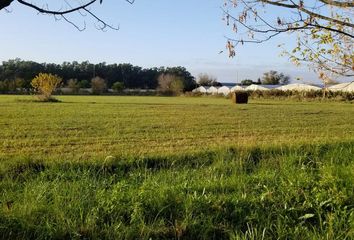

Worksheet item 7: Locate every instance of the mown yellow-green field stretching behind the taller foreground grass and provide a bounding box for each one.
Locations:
[0,96,354,161]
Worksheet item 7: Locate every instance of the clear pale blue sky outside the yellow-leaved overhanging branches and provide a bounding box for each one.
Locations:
[0,0,326,83]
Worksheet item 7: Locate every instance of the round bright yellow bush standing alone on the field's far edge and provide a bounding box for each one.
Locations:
[31,73,62,101]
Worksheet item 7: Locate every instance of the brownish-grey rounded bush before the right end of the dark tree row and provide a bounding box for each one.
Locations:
[158,74,184,95]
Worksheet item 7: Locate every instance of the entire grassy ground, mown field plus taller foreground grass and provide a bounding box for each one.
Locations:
[0,96,354,239]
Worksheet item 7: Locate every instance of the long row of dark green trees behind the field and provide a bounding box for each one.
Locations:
[0,58,196,93]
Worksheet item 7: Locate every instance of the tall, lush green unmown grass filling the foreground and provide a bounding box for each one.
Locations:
[0,141,354,239]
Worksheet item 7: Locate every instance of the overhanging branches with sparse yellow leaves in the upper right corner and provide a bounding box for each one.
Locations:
[223,0,354,81]
